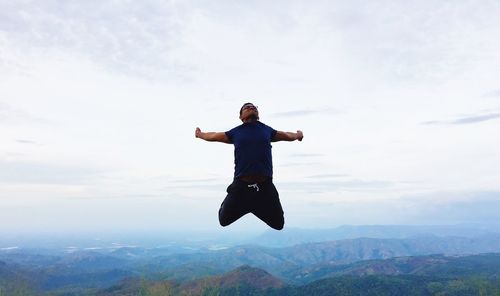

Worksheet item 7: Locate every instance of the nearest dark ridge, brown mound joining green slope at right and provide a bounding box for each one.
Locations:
[98,254,500,296]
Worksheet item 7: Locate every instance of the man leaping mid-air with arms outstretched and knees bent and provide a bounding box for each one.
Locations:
[195,103,304,230]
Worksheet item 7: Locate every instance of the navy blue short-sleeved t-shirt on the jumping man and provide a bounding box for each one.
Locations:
[226,121,276,178]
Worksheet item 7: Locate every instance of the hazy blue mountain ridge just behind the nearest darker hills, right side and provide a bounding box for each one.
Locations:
[148,235,500,282]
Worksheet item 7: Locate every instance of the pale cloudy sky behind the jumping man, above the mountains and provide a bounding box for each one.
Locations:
[0,0,500,233]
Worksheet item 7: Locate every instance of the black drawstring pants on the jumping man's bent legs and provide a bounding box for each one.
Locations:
[219,179,285,230]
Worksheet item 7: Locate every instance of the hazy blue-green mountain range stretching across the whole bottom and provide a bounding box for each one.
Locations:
[0,227,500,295]
